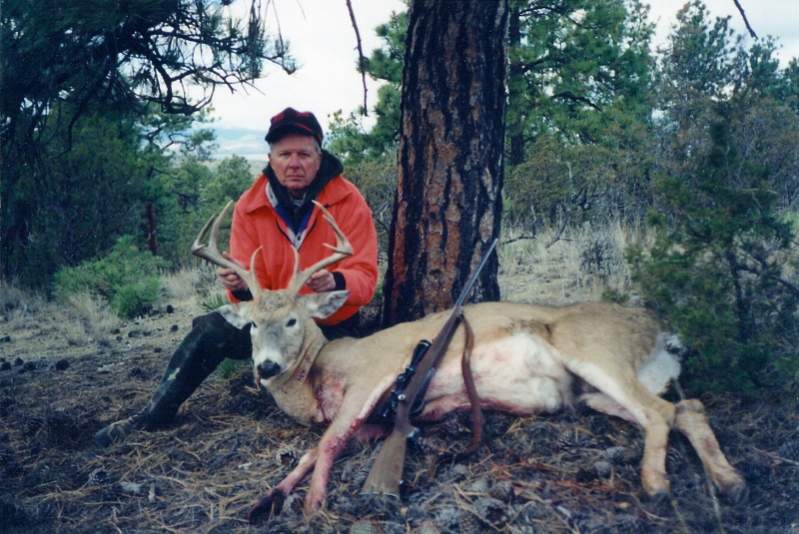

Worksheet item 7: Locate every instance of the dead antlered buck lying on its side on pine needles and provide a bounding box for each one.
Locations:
[192,200,745,514]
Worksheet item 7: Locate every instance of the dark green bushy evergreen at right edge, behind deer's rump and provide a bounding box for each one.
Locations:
[628,107,799,393]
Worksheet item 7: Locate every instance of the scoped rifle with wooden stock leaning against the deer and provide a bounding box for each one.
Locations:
[363,239,497,496]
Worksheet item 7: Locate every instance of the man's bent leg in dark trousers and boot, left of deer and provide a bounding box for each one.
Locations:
[94,312,252,447]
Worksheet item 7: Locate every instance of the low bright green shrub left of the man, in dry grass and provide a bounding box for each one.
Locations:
[54,236,165,318]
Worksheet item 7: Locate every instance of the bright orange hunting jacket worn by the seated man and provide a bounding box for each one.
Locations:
[228,174,377,325]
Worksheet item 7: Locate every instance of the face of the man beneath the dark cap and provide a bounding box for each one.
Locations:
[269,134,322,196]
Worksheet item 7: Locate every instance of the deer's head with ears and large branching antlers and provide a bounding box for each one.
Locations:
[191,201,352,387]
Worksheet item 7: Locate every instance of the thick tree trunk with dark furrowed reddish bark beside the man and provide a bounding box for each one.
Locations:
[383,0,508,325]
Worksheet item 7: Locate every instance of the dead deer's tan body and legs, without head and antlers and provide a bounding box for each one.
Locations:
[245,302,743,512]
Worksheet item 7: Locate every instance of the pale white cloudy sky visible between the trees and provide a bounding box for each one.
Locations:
[209,0,799,160]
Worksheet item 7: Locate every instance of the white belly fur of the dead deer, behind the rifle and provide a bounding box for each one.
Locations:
[421,333,572,420]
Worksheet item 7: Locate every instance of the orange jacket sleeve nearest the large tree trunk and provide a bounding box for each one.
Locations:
[334,190,377,307]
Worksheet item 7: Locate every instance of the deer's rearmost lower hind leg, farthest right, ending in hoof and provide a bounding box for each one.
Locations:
[674,399,746,502]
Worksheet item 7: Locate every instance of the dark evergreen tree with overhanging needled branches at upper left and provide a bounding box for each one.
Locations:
[0,0,293,285]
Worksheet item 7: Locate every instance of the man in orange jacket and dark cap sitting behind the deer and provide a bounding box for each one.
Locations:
[95,108,377,446]
